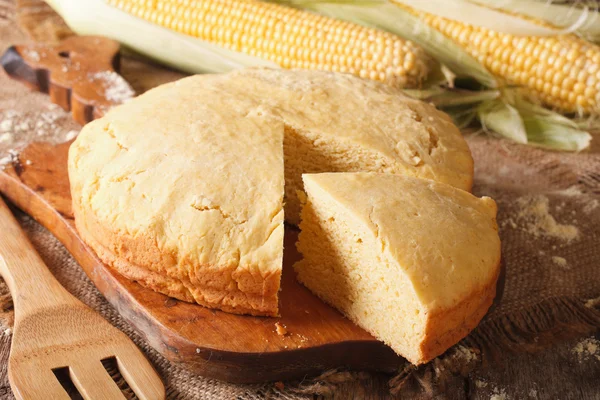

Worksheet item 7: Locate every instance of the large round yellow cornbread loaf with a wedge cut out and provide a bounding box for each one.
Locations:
[69,69,473,315]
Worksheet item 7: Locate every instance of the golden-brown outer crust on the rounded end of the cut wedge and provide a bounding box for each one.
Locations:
[418,263,500,365]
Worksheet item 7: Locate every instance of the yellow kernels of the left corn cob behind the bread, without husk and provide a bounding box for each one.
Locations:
[106,0,431,88]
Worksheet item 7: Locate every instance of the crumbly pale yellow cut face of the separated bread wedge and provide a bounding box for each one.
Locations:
[296,184,427,360]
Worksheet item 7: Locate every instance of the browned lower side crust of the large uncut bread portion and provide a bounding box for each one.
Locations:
[73,202,280,317]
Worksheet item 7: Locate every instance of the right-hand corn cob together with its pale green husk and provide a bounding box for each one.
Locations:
[284,0,600,150]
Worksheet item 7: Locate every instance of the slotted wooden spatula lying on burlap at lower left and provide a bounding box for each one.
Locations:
[0,198,165,400]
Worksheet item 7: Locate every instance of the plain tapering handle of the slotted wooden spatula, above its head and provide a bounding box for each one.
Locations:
[0,197,73,319]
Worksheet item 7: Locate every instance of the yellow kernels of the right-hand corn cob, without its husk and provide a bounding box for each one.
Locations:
[400,5,600,114]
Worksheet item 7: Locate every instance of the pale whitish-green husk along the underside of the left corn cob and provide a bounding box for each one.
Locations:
[46,0,278,73]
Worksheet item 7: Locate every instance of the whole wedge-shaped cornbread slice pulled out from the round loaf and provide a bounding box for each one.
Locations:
[295,173,500,364]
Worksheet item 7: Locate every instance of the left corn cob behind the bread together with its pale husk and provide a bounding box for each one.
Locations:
[49,0,435,88]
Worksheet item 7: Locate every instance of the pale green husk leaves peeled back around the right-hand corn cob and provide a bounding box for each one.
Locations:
[280,0,591,151]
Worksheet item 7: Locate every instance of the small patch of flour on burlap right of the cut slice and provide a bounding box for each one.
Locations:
[505,195,579,241]
